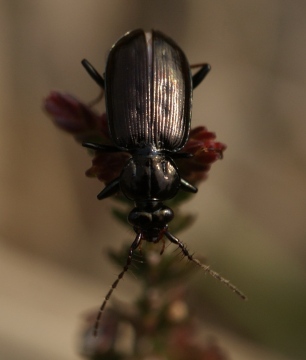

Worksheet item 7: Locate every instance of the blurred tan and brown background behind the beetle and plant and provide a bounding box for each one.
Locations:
[0,0,306,360]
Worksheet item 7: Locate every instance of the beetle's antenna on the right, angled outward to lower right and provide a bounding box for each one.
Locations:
[165,231,247,300]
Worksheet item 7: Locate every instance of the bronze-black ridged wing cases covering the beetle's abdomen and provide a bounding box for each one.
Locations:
[105,30,192,151]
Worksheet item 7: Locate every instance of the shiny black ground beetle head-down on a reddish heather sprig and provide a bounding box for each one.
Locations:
[82,29,245,334]
